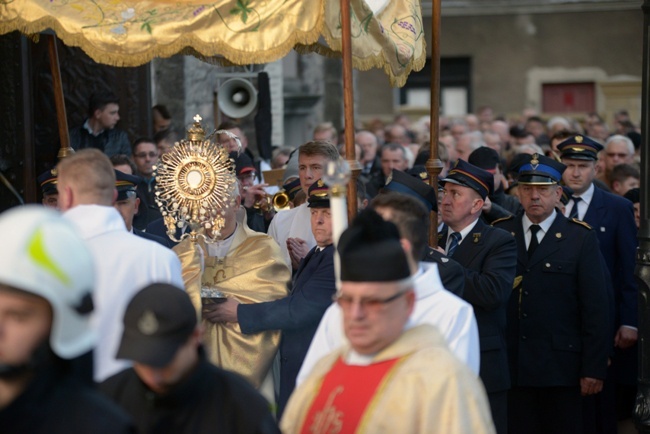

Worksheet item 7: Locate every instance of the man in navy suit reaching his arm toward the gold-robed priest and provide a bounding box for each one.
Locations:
[208,180,336,419]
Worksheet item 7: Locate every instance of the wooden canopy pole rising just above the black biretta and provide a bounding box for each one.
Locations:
[340,0,361,221]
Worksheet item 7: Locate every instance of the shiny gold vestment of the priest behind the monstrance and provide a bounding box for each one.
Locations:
[174,223,291,388]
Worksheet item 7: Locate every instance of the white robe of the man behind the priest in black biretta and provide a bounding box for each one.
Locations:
[296,262,481,385]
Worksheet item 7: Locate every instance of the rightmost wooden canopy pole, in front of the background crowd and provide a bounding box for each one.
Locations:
[425,0,443,247]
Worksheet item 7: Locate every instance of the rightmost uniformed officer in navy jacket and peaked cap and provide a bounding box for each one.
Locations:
[557,134,638,434]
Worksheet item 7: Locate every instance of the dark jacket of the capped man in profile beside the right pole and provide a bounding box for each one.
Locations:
[439,219,517,393]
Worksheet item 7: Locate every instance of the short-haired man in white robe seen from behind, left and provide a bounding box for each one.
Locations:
[57,149,183,381]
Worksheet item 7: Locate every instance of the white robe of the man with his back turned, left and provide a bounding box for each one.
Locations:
[63,205,185,381]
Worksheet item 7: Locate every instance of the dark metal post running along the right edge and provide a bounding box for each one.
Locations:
[634,0,650,433]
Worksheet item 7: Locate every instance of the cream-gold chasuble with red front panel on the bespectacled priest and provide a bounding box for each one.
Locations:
[280,324,496,434]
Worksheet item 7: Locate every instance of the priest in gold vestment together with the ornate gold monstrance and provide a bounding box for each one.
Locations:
[156,116,291,397]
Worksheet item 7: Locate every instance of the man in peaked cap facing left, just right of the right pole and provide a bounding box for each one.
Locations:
[440,160,517,434]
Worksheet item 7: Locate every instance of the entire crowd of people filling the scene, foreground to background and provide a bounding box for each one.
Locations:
[0,90,640,434]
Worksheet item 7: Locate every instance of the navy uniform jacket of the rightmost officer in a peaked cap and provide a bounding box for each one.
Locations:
[583,184,638,328]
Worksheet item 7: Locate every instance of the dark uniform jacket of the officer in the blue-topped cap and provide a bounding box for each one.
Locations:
[495,212,611,387]
